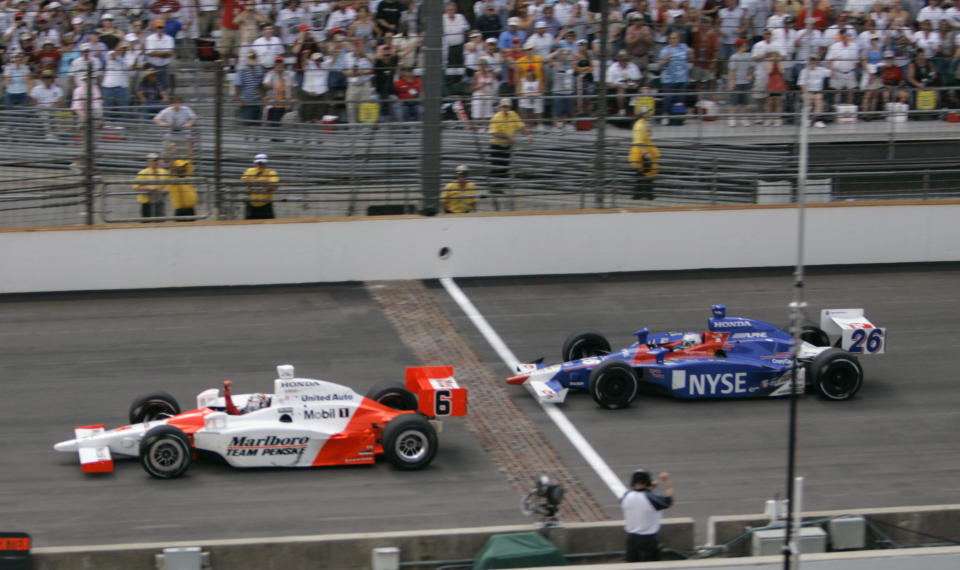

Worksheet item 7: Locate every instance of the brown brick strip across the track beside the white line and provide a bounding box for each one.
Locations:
[365,281,609,522]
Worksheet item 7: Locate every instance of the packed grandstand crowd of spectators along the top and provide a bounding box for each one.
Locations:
[0,0,960,131]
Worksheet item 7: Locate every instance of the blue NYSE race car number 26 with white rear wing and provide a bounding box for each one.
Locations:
[507,305,886,409]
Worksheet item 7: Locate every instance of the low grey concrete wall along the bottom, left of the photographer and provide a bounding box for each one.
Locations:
[33,518,694,570]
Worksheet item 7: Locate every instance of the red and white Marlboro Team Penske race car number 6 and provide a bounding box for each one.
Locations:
[53,364,467,479]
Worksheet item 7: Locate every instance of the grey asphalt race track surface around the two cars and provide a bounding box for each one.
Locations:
[0,265,960,546]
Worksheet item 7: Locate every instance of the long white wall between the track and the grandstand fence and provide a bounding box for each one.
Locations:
[0,200,960,293]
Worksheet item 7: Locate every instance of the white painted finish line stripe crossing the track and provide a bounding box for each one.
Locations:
[440,277,627,500]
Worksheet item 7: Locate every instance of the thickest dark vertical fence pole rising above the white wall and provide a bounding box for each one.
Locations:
[420,0,443,215]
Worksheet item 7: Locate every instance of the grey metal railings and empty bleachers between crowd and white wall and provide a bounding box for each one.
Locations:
[0,80,960,227]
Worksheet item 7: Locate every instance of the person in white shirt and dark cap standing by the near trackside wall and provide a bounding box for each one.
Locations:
[620,469,676,562]
